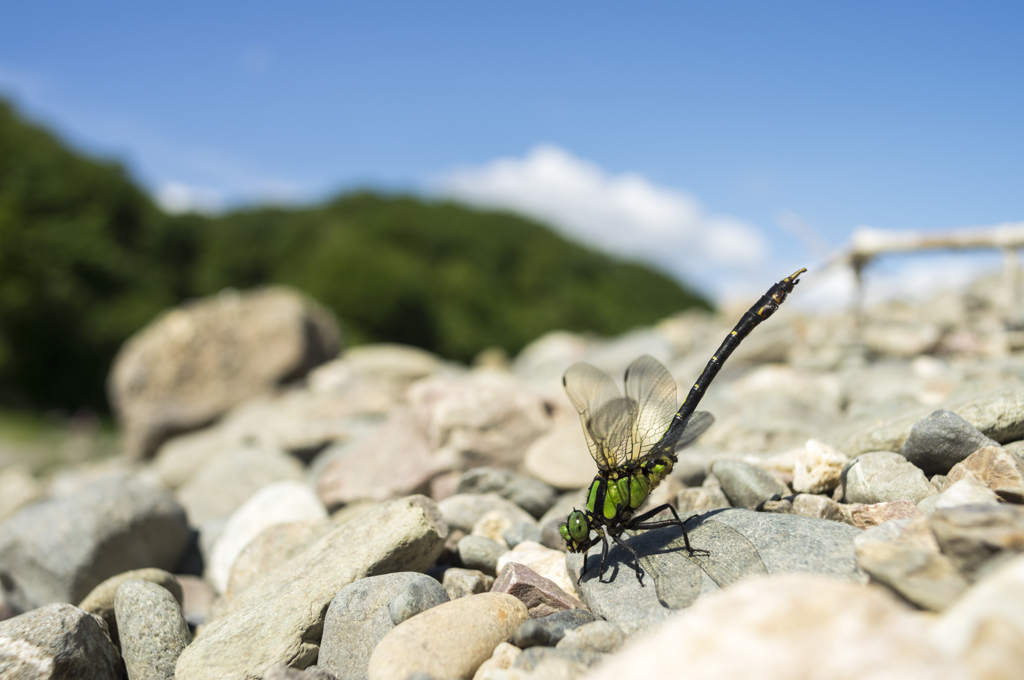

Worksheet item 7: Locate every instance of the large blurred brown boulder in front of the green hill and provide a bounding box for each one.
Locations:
[109,287,340,458]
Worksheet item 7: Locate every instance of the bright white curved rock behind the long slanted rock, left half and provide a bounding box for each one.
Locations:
[206,481,327,593]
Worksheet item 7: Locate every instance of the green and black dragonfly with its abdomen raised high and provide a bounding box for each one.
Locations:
[558,268,807,586]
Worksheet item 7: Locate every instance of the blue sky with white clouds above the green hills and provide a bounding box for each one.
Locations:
[0,0,1024,303]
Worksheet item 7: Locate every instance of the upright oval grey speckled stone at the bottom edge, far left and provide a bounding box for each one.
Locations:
[114,579,191,680]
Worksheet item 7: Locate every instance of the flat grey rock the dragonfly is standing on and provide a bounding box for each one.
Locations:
[566,508,863,636]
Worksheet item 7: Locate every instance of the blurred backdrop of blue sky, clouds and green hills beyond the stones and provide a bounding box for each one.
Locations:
[0,0,1024,456]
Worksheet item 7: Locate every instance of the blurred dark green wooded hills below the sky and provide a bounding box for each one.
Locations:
[0,97,706,409]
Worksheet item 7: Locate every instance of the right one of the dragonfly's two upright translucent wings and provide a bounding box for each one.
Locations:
[626,354,676,461]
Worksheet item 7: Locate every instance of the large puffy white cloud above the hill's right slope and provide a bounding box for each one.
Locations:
[435,145,769,292]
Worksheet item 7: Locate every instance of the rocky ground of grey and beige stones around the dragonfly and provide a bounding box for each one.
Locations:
[0,274,1024,680]
